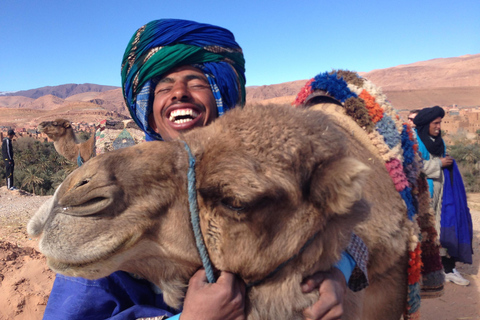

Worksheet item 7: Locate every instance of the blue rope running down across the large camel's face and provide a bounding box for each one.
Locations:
[183,141,217,283]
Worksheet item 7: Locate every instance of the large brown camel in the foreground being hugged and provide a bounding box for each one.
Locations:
[28,104,426,320]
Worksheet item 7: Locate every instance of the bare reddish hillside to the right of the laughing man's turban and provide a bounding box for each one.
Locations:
[247,54,480,109]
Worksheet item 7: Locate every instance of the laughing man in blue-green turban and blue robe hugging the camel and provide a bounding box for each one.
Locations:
[45,19,365,320]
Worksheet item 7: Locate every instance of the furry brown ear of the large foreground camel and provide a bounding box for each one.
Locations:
[310,157,371,214]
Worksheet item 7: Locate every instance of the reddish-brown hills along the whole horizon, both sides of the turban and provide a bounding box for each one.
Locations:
[0,54,480,127]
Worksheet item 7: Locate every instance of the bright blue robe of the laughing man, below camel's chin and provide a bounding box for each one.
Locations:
[43,271,179,320]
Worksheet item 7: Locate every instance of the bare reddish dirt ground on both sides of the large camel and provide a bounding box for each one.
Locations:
[0,187,480,320]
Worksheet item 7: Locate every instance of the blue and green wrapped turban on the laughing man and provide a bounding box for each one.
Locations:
[122,19,245,141]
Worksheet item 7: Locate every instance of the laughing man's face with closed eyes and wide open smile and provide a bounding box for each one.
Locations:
[148,66,217,141]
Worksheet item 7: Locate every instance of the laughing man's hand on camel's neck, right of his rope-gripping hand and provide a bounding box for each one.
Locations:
[302,268,347,320]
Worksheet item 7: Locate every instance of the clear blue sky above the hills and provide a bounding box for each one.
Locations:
[0,0,480,91]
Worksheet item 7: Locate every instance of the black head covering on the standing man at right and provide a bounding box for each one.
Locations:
[413,106,445,157]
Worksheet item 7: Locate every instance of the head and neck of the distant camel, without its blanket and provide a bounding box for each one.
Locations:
[38,119,95,163]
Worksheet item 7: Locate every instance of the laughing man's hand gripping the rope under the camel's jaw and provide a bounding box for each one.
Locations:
[180,269,245,320]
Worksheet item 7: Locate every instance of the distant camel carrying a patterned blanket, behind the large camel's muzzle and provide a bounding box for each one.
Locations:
[38,119,145,166]
